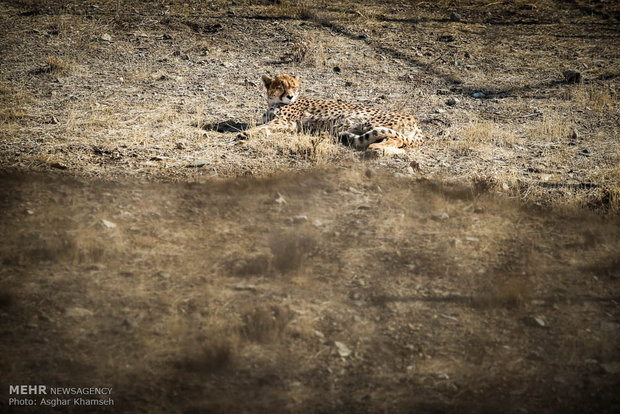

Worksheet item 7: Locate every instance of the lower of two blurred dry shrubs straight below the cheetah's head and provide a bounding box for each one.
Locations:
[241,305,294,343]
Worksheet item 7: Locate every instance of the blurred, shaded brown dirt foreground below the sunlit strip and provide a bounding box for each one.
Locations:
[0,169,620,412]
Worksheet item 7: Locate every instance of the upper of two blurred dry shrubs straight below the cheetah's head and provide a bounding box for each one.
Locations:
[269,233,316,274]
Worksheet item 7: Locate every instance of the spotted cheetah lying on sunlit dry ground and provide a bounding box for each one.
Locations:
[237,75,423,152]
